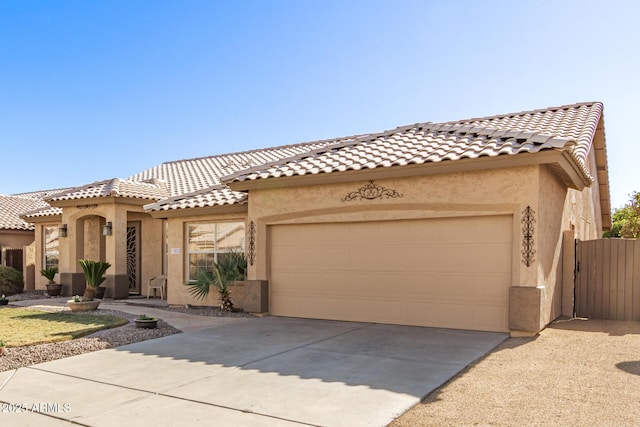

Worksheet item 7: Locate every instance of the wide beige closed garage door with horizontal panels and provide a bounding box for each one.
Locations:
[270,216,512,331]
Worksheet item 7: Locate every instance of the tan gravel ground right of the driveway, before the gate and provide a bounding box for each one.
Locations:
[389,319,640,427]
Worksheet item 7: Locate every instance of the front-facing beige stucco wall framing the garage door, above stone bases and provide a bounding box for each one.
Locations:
[249,166,539,286]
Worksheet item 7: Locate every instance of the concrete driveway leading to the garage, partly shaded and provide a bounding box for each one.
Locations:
[0,317,507,427]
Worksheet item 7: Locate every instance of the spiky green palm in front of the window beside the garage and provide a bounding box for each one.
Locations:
[186,252,247,311]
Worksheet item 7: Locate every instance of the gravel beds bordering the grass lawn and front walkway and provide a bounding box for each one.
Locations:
[0,291,252,372]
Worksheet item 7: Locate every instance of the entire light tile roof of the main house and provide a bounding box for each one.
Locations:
[11,102,602,217]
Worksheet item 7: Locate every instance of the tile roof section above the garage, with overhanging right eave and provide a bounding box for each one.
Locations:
[223,102,602,183]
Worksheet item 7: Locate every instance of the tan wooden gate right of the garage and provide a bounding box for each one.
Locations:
[574,239,640,320]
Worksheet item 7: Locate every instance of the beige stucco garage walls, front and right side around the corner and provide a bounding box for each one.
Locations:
[241,165,600,331]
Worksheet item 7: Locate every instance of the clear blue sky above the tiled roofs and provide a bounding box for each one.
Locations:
[0,0,640,211]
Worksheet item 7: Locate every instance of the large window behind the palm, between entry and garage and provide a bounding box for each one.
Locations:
[187,222,245,280]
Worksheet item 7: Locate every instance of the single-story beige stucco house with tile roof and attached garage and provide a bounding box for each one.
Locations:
[18,102,611,335]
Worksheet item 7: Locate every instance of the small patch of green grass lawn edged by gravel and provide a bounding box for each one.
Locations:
[0,307,129,347]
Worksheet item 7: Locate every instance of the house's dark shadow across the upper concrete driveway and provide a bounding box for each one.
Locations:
[109,317,507,398]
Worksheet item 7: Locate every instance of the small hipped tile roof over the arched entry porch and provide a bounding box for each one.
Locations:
[44,178,168,202]
